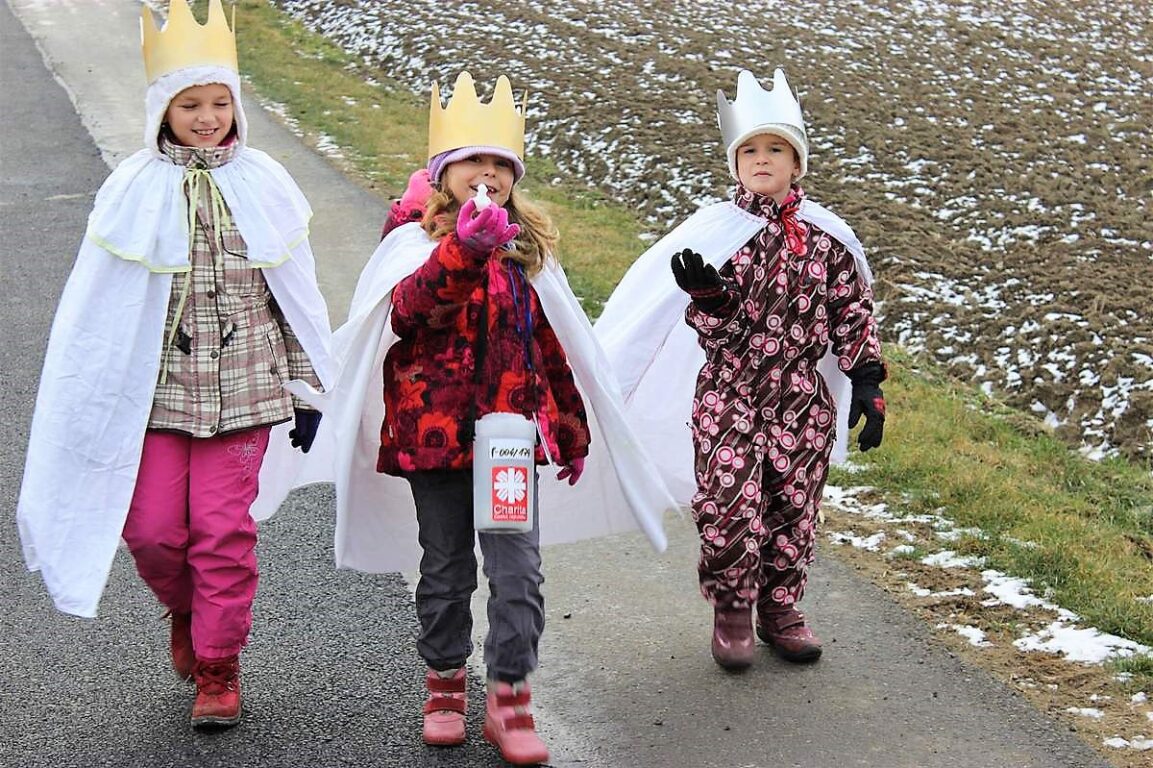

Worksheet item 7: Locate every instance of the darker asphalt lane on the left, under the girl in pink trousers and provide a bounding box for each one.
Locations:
[0,3,502,768]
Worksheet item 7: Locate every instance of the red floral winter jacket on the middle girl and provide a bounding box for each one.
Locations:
[377,234,589,475]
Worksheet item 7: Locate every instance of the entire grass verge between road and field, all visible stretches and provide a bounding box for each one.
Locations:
[227,0,1153,685]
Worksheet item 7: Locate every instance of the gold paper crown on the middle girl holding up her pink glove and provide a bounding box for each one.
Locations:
[429,71,528,159]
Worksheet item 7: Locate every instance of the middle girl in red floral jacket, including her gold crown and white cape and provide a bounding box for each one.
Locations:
[299,73,673,765]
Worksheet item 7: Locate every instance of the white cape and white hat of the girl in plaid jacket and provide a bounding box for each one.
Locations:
[16,67,332,617]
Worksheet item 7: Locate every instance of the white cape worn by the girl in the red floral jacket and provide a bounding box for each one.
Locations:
[254,224,677,573]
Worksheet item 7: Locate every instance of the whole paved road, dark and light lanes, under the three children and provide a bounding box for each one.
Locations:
[0,0,1105,768]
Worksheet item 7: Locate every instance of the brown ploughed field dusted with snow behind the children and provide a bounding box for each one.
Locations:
[276,0,1153,461]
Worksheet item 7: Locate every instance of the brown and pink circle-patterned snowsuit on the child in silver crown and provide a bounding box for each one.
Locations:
[686,187,881,610]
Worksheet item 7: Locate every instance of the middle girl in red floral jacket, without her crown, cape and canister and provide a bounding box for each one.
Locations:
[377,75,589,765]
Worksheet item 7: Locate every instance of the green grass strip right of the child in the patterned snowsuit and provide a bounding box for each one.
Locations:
[834,347,1153,646]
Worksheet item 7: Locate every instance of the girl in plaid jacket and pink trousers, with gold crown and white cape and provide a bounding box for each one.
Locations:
[17,0,331,728]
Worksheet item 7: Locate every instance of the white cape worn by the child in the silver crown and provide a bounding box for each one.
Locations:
[594,199,873,504]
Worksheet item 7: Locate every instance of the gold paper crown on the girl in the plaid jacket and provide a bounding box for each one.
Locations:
[141,0,240,83]
